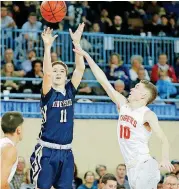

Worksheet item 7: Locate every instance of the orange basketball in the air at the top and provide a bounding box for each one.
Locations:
[40,1,67,23]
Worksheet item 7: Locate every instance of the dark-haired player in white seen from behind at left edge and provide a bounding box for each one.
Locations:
[0,112,24,189]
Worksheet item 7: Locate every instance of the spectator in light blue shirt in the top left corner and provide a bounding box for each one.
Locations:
[1,6,16,29]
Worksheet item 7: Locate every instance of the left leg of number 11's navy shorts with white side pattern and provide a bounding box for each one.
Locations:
[30,144,56,189]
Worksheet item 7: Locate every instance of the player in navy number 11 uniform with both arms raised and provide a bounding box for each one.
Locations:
[30,23,85,189]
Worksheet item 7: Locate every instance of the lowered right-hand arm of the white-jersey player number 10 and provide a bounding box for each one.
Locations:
[144,111,174,172]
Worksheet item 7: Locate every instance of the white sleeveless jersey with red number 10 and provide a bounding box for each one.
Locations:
[117,104,151,168]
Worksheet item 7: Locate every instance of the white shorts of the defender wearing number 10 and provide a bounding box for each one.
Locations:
[127,158,160,189]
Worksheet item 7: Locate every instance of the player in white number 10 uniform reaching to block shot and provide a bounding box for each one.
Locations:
[74,48,174,189]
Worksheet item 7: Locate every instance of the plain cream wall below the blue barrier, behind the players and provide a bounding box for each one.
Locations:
[0,118,179,176]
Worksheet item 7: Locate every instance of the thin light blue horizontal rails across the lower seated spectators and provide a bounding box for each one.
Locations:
[1,77,179,102]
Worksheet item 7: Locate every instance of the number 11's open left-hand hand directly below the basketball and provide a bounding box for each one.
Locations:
[41,27,58,47]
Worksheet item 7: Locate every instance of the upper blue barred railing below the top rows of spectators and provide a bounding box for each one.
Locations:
[1,29,179,66]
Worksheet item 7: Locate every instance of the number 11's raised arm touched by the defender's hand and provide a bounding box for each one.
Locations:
[69,23,85,89]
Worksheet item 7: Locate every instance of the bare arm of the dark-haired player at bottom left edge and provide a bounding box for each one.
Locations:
[0,145,17,189]
